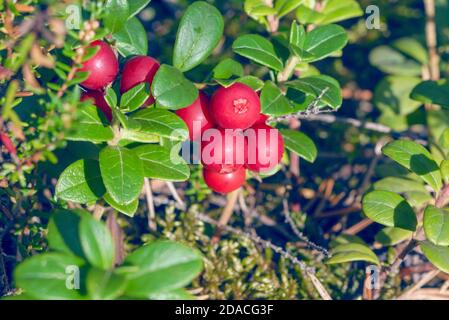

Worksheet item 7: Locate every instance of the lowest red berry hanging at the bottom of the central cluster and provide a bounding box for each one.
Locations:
[203,167,246,193]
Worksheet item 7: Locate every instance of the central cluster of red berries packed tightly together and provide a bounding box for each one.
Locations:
[176,83,284,193]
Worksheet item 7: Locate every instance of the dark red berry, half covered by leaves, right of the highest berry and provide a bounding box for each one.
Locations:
[120,56,160,106]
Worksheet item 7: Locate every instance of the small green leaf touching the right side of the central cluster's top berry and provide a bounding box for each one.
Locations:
[260,81,295,116]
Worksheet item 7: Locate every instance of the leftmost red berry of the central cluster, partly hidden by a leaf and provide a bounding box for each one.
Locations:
[176,92,212,141]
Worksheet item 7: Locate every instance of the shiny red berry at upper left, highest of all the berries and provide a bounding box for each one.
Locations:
[80,40,118,90]
